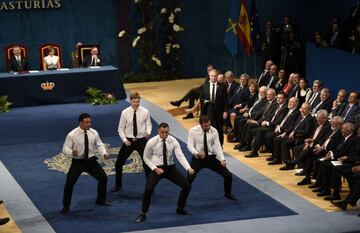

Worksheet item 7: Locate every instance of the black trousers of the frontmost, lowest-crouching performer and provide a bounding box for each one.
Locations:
[142,165,191,213]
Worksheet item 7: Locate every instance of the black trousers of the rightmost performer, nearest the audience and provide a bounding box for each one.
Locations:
[187,155,232,196]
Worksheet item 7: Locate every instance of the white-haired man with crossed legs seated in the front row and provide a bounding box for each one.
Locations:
[284,109,332,185]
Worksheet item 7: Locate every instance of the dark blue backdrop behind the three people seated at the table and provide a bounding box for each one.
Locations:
[0,0,118,71]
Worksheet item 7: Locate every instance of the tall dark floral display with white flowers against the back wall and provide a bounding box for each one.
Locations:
[118,0,185,82]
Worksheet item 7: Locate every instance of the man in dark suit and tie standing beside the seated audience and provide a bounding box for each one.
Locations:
[200,69,228,145]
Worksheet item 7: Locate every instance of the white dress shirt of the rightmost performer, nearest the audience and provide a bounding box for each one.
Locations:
[187,125,225,161]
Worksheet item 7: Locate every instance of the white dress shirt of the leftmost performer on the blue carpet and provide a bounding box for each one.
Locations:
[62,127,107,159]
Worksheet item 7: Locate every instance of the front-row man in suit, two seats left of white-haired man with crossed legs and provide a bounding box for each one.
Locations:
[265,97,300,160]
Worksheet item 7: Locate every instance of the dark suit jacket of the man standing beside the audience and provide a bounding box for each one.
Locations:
[200,82,228,116]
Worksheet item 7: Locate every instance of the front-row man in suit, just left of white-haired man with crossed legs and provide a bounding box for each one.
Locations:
[273,102,314,167]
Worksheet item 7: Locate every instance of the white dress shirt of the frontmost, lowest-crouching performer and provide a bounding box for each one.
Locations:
[144,135,190,170]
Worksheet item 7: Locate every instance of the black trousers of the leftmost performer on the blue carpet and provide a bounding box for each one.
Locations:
[63,157,107,206]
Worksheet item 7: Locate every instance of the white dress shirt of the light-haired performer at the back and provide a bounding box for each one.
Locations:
[118,106,152,142]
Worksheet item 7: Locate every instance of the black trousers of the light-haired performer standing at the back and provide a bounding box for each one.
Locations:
[115,138,150,187]
